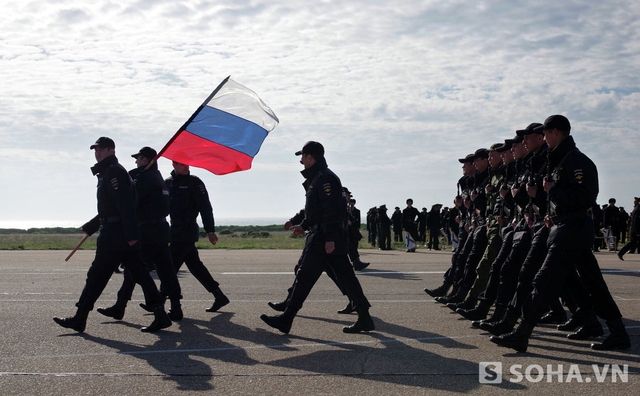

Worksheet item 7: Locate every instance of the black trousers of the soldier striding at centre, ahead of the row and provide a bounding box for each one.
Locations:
[287,233,371,311]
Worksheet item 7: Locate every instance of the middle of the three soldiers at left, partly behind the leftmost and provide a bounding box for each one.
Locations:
[98,147,183,321]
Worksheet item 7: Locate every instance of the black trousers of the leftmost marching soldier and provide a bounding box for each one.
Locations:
[76,248,162,311]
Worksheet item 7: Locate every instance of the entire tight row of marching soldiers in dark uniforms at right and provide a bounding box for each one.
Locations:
[425,115,630,352]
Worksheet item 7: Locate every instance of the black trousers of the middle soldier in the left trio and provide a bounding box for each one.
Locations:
[118,244,182,302]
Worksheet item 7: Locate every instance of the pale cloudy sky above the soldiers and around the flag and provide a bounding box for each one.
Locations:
[0,0,640,228]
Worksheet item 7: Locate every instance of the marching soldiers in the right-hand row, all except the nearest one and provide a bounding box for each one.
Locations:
[425,122,630,352]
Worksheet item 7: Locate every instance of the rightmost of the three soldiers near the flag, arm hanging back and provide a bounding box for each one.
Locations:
[163,161,229,312]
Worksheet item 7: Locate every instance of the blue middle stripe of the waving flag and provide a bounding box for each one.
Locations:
[185,106,268,157]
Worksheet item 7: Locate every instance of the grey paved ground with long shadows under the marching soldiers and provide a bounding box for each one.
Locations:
[0,249,640,395]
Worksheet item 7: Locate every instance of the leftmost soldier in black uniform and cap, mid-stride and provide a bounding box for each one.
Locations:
[53,137,171,333]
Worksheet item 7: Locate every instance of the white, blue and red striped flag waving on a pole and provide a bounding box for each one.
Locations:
[158,77,279,175]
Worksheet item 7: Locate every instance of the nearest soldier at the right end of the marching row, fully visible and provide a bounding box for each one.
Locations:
[491,115,631,352]
